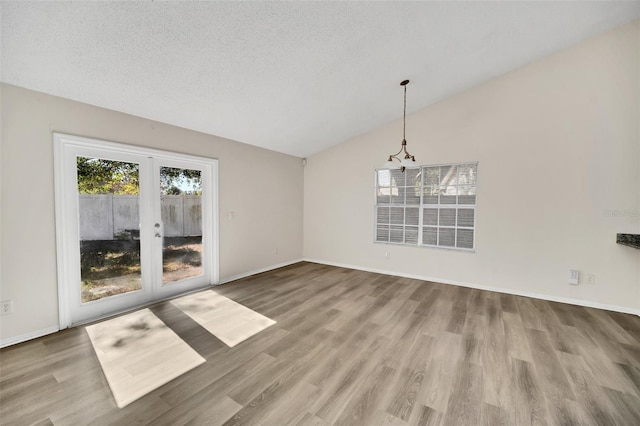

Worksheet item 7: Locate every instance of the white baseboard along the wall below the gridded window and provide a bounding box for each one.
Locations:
[302,258,640,316]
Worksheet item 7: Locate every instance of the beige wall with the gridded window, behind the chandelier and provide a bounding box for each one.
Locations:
[304,21,640,312]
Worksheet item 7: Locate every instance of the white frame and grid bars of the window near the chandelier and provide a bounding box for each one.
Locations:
[373,161,478,253]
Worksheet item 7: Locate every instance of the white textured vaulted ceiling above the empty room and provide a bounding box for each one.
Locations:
[0,1,640,157]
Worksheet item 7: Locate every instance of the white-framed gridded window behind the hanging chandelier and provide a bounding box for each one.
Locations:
[375,163,477,250]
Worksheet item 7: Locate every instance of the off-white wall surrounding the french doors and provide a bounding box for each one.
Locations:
[0,84,303,341]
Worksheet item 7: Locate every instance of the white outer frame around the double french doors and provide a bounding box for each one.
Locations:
[53,132,220,329]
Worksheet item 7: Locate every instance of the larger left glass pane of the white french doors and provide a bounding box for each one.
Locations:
[76,156,142,303]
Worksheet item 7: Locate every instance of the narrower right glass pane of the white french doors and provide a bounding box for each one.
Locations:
[160,166,203,286]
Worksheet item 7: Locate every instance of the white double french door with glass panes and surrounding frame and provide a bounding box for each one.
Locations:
[54,134,218,328]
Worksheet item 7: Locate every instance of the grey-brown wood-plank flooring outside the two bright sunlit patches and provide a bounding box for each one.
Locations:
[0,262,640,426]
